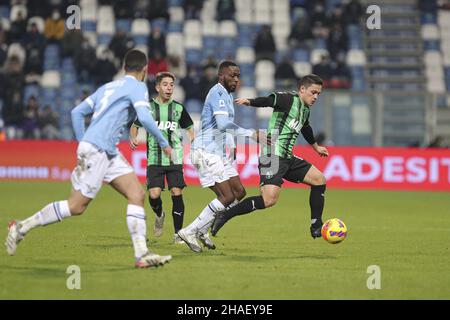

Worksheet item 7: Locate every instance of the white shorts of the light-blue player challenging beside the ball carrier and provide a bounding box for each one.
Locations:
[191,149,239,188]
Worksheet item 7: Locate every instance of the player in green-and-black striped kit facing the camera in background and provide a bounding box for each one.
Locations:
[130,72,194,243]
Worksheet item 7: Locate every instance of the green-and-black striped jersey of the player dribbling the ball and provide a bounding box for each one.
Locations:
[262,92,309,159]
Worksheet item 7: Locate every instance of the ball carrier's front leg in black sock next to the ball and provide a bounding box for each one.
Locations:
[303,166,326,238]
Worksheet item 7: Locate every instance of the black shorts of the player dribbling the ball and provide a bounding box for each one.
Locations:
[258,156,312,187]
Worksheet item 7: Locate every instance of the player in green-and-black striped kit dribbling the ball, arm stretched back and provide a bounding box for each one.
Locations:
[211,74,328,238]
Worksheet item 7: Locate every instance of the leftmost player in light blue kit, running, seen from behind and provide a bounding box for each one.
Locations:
[5,50,172,268]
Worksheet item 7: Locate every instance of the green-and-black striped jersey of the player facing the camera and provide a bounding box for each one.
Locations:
[133,99,193,166]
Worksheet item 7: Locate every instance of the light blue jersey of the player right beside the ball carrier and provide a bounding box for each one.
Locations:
[192,83,253,157]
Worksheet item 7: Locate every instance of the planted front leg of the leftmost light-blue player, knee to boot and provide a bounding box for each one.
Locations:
[110,172,172,268]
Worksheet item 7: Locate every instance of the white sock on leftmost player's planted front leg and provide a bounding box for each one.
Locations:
[127,204,148,259]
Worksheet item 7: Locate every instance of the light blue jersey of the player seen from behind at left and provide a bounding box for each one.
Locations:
[72,75,168,156]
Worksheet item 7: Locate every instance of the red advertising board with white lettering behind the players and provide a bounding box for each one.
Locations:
[0,141,450,191]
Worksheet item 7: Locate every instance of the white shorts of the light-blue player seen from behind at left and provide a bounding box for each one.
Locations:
[71,141,133,199]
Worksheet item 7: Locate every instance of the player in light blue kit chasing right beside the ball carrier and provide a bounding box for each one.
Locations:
[178,61,257,252]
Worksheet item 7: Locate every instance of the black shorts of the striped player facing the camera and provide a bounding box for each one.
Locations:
[147,164,186,190]
